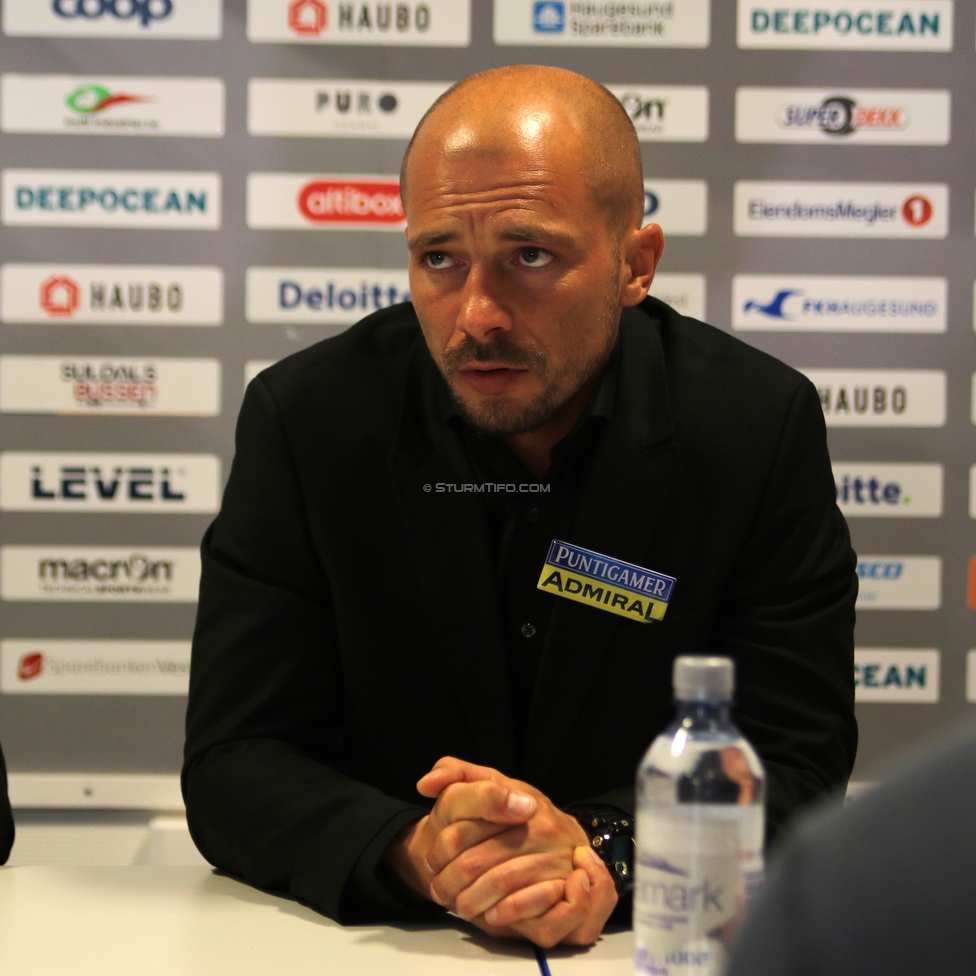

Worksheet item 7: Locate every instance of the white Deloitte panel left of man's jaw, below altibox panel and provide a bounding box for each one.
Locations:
[245,268,410,326]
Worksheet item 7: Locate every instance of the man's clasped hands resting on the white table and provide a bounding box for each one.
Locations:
[387,758,617,948]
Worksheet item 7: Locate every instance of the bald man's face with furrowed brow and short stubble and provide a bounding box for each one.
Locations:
[405,125,622,435]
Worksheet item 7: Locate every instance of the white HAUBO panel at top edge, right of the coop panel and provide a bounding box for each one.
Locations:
[247,0,471,47]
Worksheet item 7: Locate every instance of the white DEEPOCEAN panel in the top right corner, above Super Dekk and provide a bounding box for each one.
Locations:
[737,0,953,51]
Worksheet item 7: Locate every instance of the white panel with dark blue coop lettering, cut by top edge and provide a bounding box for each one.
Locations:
[3,0,221,40]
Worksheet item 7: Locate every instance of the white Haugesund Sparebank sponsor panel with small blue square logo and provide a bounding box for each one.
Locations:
[494,0,711,47]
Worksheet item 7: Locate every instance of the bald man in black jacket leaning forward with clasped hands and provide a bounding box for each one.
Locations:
[183,66,857,946]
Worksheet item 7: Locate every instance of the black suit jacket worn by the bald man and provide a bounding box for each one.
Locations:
[183,299,857,917]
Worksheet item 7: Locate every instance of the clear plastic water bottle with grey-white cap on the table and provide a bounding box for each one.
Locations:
[634,656,766,976]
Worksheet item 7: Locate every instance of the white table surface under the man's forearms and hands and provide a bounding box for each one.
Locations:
[0,867,633,976]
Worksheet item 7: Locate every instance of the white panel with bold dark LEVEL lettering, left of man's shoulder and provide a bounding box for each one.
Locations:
[0,451,220,515]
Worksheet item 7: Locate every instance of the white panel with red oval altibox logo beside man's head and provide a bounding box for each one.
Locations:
[247,173,406,231]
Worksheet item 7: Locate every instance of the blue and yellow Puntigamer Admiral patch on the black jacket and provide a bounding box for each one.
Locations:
[538,539,676,623]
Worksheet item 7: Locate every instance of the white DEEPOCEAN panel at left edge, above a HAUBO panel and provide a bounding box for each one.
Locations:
[0,169,220,230]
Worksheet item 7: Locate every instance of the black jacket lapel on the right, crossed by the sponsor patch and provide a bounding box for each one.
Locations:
[524,310,680,782]
